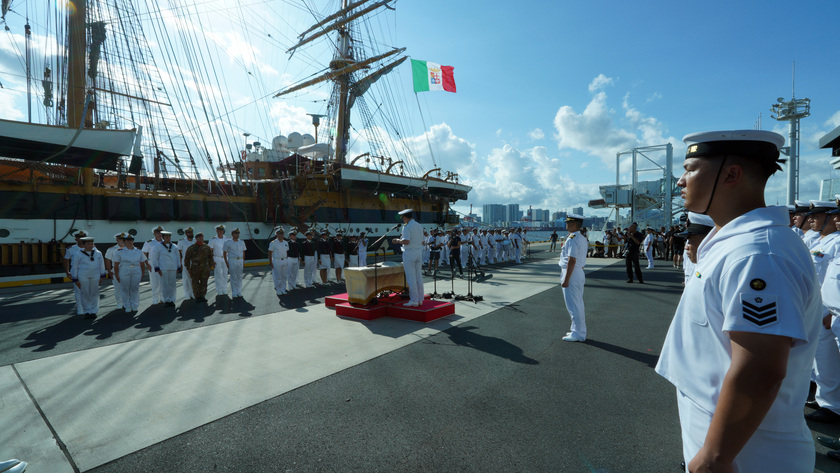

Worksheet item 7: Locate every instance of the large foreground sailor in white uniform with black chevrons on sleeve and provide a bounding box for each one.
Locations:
[656,130,822,473]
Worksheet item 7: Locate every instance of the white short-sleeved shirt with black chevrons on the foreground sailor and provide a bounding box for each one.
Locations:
[656,207,822,432]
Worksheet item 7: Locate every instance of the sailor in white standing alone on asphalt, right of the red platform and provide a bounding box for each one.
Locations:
[559,214,589,342]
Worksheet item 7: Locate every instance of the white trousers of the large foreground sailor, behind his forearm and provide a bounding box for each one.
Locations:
[677,389,815,473]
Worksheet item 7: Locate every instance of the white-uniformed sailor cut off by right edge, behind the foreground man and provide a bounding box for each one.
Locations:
[805,200,840,423]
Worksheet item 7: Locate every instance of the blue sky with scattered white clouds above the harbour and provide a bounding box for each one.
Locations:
[0,0,840,219]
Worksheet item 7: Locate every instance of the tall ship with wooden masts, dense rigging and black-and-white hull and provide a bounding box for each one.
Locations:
[0,0,471,282]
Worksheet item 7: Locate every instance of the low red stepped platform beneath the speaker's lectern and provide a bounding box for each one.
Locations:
[332,294,455,323]
